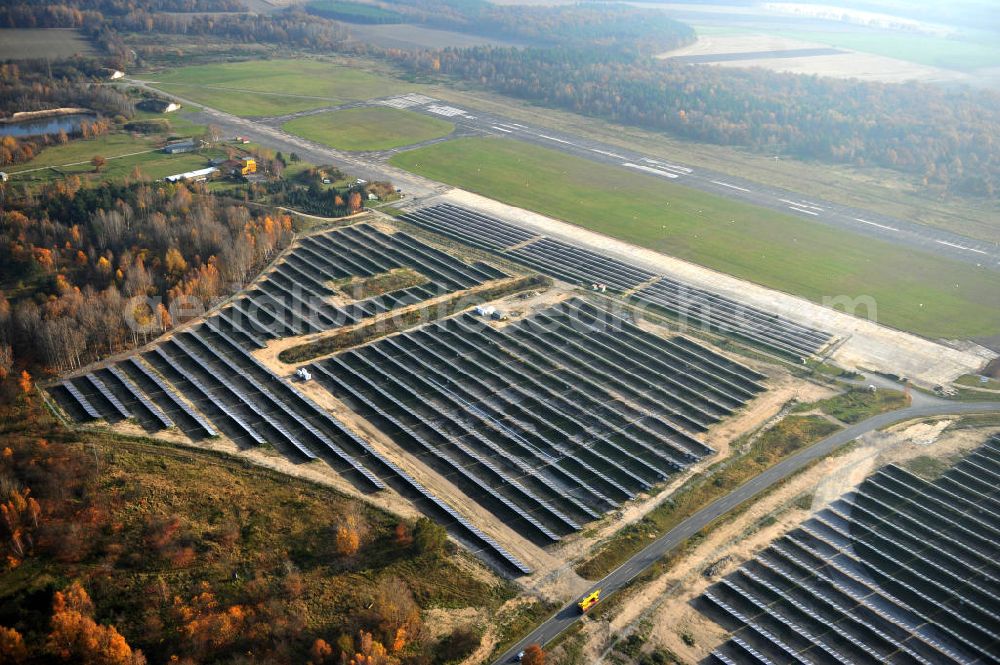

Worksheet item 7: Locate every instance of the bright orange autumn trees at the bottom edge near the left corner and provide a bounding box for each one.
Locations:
[47,582,146,665]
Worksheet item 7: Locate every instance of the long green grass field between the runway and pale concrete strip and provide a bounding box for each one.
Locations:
[391,138,1000,337]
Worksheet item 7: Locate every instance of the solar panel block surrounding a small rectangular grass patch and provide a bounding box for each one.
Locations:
[213,224,506,348]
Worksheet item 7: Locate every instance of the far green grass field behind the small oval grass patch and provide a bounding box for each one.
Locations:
[143,60,413,116]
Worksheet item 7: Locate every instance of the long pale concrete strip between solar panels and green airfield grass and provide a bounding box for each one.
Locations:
[439,190,996,387]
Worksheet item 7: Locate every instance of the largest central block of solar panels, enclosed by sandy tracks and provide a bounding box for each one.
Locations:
[310,299,764,544]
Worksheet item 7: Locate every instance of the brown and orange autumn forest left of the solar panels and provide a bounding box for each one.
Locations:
[0,176,293,377]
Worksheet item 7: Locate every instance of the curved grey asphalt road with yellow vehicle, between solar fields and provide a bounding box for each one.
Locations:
[494,393,1000,665]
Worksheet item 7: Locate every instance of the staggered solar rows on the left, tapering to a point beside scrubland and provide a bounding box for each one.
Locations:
[53,316,531,574]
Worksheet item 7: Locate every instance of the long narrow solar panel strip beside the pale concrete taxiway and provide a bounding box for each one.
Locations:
[401,204,831,358]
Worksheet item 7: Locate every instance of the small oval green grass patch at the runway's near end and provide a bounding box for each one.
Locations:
[284,107,455,150]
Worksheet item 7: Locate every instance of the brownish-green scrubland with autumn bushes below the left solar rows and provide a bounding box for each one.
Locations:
[0,391,513,662]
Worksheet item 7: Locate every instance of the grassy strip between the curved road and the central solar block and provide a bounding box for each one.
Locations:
[575,390,905,580]
